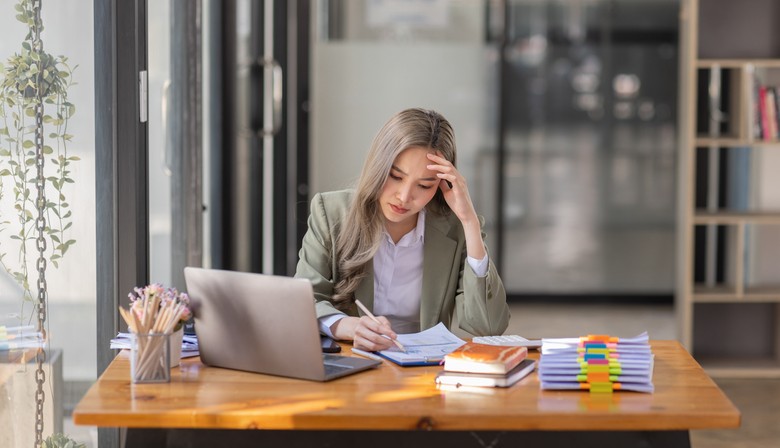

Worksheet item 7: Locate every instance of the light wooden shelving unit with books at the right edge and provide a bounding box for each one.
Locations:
[676,0,780,377]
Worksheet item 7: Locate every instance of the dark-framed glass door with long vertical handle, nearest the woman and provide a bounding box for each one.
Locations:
[204,0,298,274]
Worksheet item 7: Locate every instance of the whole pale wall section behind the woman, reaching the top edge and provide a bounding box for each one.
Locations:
[310,0,497,207]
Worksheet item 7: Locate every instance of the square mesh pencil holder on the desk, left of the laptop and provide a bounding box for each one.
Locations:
[130,333,171,383]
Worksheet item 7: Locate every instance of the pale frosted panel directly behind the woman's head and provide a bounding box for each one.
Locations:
[310,43,494,193]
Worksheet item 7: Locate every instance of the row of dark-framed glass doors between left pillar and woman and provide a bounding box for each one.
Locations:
[148,0,299,289]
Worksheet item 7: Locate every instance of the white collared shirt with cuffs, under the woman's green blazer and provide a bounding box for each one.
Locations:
[319,209,488,337]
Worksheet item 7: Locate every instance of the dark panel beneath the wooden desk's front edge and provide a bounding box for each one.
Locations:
[123,428,691,448]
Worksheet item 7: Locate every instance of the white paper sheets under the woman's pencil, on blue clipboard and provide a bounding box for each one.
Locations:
[377,322,466,366]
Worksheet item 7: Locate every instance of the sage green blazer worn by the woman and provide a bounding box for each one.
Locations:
[295,190,509,336]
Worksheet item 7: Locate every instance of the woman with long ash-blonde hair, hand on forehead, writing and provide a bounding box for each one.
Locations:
[295,109,509,350]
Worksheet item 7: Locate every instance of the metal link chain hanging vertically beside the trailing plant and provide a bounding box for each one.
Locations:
[32,0,48,448]
